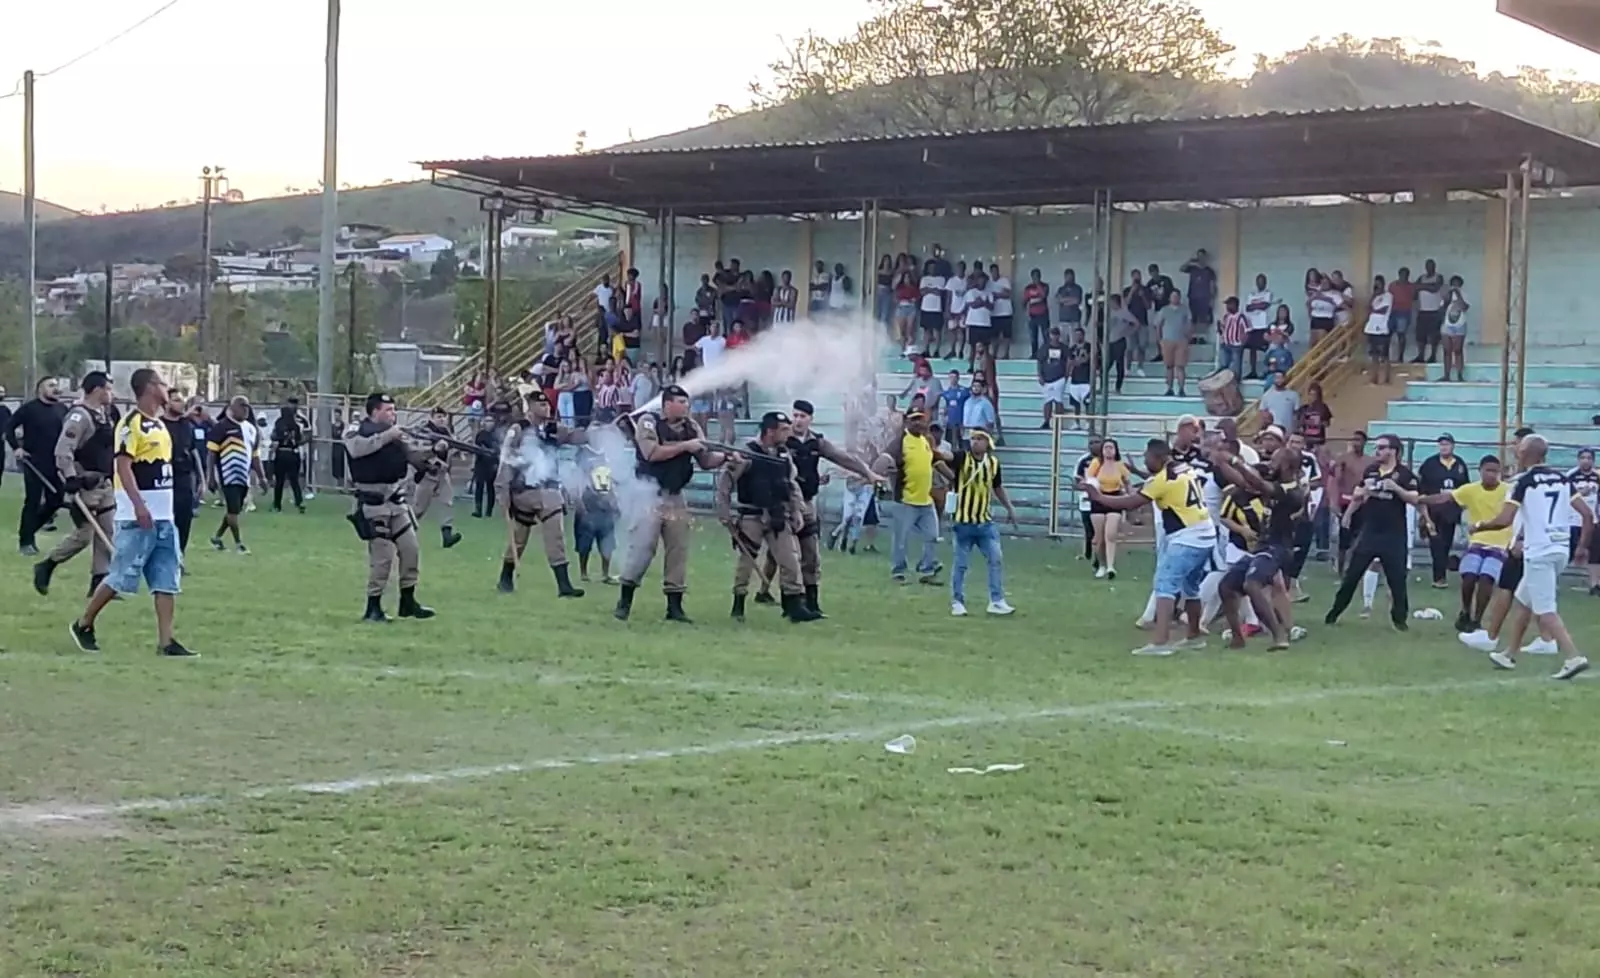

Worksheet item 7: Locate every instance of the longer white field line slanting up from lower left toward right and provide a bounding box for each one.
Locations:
[0,679,1525,829]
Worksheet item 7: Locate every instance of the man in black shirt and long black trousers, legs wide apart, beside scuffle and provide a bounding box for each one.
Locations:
[1326,435,1419,632]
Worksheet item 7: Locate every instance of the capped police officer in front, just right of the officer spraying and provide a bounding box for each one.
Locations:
[717,411,821,624]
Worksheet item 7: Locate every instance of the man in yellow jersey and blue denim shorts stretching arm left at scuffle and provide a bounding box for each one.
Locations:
[1083,439,1216,656]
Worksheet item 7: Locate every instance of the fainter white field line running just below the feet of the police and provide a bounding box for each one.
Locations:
[0,651,957,709]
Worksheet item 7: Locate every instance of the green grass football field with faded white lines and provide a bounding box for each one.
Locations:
[0,485,1600,978]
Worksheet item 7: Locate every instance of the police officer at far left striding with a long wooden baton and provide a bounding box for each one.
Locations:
[34,370,117,594]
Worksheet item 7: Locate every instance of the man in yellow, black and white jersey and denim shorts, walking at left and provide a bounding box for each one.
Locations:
[70,368,195,658]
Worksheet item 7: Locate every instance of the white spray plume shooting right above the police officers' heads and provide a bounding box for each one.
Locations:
[643,314,888,428]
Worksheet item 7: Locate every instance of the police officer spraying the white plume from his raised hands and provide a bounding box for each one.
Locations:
[613,384,726,623]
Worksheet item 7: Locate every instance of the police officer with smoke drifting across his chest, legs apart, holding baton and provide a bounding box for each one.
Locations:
[494,384,587,597]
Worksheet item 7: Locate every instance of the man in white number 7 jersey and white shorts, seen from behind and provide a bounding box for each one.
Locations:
[1469,434,1595,679]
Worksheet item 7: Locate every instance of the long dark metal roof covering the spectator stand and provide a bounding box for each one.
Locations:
[422,102,1600,218]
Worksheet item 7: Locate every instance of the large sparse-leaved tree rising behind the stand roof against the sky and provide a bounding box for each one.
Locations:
[752,0,1232,138]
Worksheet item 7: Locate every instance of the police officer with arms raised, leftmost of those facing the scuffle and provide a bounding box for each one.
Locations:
[344,392,434,621]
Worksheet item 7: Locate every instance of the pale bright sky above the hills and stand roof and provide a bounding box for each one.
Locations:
[0,0,1600,211]
